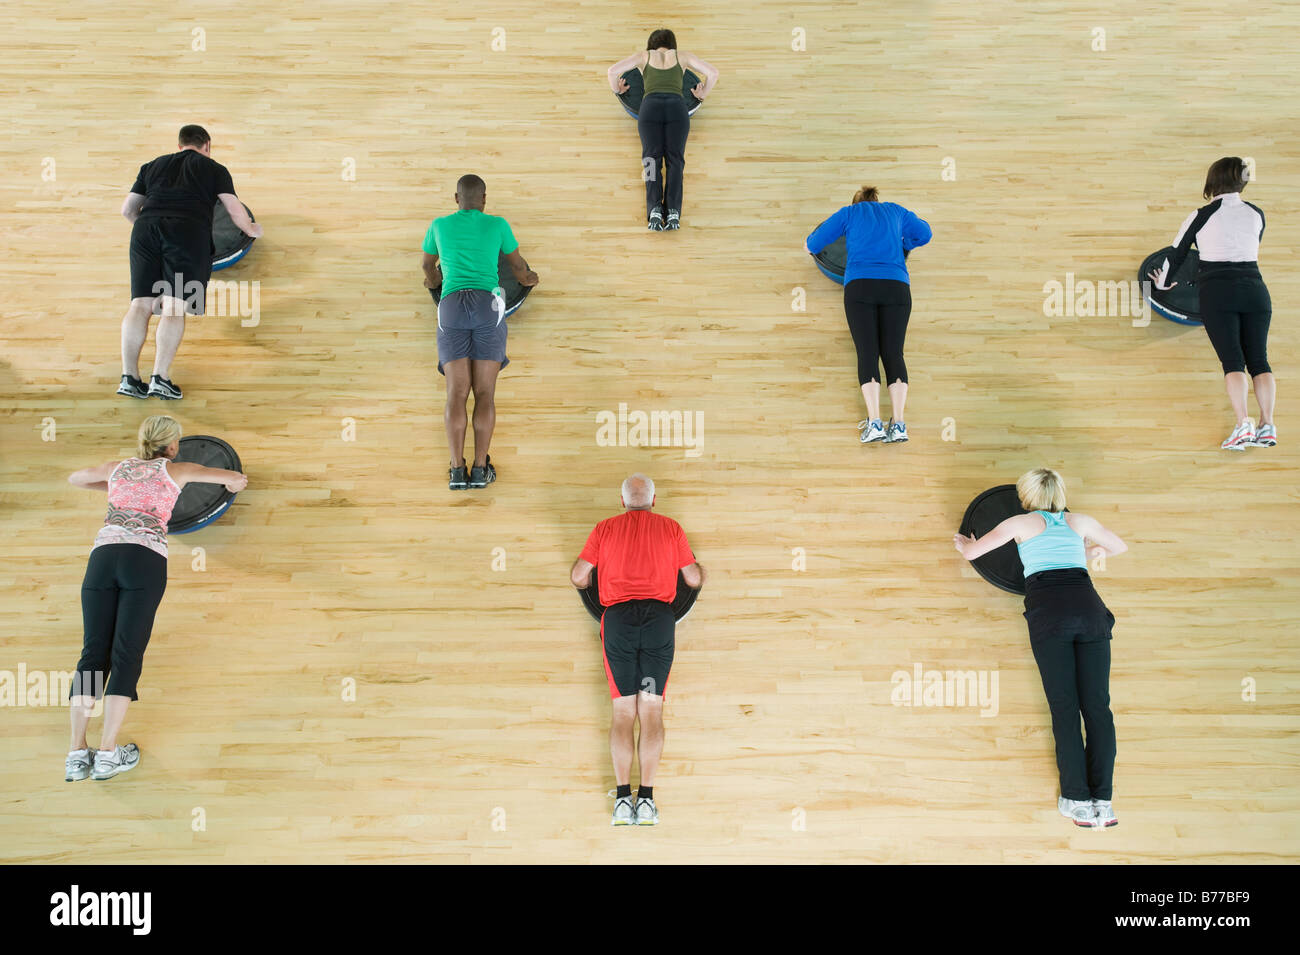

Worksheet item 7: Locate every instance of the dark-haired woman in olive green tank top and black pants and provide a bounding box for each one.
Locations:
[610,30,718,231]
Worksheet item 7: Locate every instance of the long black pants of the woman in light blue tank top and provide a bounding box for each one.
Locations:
[1024,568,1115,800]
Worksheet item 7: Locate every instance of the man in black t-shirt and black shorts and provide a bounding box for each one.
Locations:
[117,126,261,399]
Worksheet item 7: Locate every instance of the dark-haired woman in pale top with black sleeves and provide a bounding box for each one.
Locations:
[1151,156,1278,451]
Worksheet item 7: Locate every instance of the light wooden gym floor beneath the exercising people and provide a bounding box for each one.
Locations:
[0,0,1300,863]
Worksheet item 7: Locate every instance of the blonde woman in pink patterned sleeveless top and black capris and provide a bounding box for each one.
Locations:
[66,414,248,782]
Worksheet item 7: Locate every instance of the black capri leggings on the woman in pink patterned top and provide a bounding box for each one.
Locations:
[69,544,166,700]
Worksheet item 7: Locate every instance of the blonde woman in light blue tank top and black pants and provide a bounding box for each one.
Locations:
[953,468,1128,829]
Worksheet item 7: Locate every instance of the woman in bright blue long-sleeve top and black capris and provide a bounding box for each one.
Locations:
[803,186,931,444]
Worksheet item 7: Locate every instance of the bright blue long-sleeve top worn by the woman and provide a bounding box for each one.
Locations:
[807,203,932,285]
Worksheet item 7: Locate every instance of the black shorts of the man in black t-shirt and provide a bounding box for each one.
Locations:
[131,216,212,314]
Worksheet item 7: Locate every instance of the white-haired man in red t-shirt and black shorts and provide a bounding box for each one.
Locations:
[569,474,705,825]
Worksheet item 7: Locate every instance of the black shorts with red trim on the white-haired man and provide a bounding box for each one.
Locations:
[601,600,677,699]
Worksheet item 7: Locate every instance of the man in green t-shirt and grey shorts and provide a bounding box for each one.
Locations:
[424,175,538,491]
